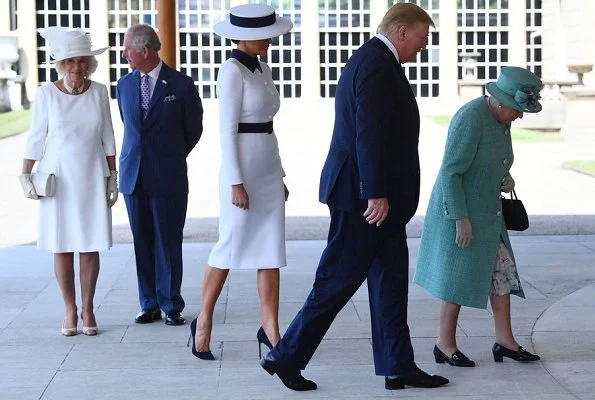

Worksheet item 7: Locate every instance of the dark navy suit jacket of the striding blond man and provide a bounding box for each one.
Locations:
[320,37,420,225]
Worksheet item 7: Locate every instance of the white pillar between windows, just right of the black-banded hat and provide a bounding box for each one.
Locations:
[301,1,320,101]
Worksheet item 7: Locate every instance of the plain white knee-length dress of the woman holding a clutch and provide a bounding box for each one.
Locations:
[24,82,116,253]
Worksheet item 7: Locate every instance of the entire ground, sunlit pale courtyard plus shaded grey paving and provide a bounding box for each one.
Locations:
[0,100,595,400]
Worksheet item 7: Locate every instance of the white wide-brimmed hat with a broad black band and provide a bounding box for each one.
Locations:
[214,4,293,40]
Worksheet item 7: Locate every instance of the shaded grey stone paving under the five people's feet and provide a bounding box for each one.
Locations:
[0,236,595,400]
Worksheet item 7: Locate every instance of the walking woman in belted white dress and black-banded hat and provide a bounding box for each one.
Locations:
[190,4,293,360]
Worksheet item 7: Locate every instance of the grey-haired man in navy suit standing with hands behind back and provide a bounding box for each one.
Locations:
[116,24,202,325]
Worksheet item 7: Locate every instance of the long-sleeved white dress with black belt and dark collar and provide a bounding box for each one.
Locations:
[208,58,287,269]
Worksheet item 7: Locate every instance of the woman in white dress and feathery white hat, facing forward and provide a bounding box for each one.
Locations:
[19,27,118,336]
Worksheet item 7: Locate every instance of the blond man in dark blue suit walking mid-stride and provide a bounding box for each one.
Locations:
[261,3,448,390]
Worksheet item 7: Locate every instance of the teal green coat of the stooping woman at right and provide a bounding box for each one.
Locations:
[414,97,524,308]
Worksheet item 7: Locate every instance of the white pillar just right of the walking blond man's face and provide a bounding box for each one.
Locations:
[434,1,459,109]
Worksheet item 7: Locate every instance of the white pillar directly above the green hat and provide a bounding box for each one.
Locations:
[508,1,527,68]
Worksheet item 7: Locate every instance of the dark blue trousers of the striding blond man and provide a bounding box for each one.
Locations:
[271,208,415,376]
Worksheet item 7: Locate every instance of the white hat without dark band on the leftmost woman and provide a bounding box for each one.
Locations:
[39,26,109,63]
